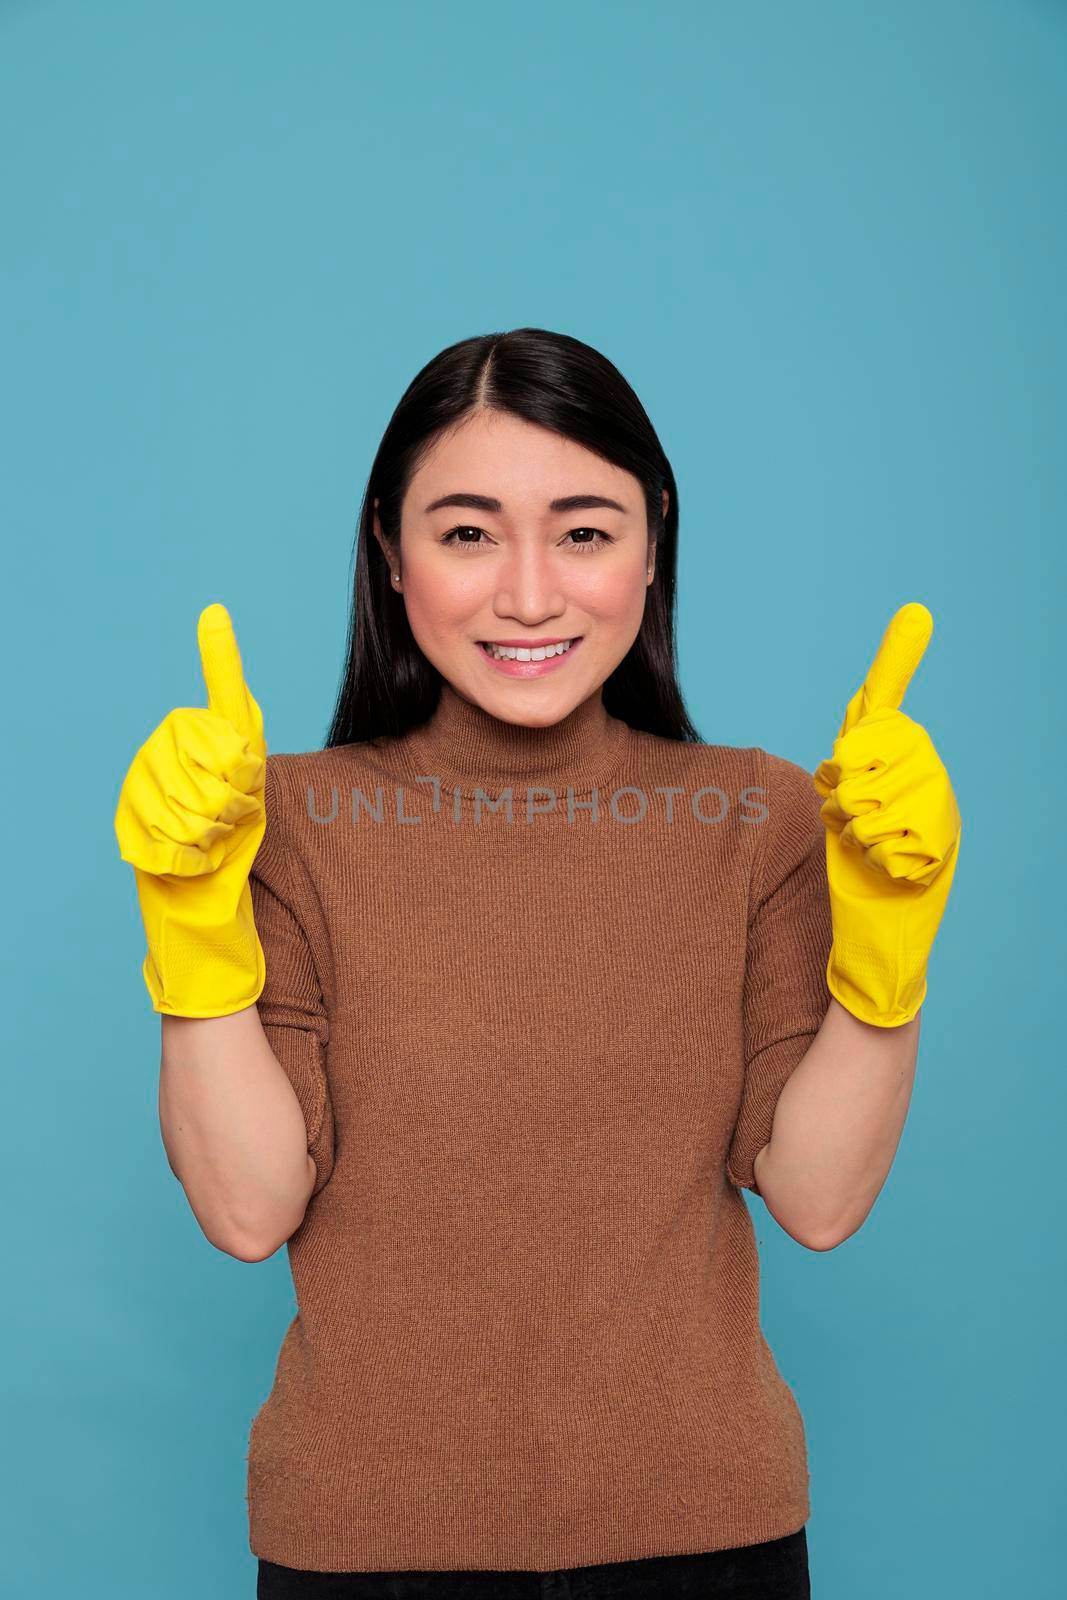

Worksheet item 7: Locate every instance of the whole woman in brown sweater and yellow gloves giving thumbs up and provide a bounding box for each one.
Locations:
[117,328,958,1600]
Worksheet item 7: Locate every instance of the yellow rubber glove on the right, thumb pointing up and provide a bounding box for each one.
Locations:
[814,603,961,1027]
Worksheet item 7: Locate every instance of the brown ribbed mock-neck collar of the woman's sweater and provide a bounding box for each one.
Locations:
[383,678,630,795]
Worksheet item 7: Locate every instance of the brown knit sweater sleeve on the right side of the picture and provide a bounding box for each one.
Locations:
[726,750,833,1194]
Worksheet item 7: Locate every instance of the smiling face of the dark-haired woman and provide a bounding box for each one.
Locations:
[374,411,667,726]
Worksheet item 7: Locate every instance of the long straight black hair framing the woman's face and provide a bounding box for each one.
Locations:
[325,328,699,749]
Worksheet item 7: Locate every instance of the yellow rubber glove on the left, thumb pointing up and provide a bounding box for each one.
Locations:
[115,605,267,1018]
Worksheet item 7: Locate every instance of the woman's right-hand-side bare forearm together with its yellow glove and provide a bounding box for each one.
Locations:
[752,602,961,1250]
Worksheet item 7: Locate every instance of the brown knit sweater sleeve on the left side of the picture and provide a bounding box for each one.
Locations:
[250,755,334,1195]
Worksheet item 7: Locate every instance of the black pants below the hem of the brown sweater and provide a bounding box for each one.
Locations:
[256,1528,811,1600]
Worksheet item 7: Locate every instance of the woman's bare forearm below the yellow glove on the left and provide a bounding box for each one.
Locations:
[160,1005,315,1261]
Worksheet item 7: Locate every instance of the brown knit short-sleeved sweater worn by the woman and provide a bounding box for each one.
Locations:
[241,683,830,1571]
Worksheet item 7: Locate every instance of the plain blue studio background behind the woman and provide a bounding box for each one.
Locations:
[0,0,1067,1600]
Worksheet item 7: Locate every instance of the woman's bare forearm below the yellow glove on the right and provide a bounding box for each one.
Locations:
[755,998,921,1250]
